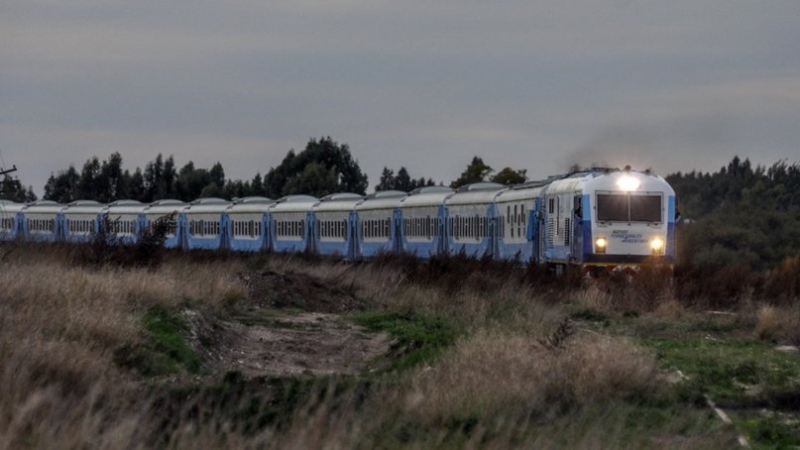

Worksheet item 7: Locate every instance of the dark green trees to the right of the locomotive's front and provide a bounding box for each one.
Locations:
[666,156,800,270]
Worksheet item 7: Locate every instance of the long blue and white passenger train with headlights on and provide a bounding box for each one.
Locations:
[0,167,679,271]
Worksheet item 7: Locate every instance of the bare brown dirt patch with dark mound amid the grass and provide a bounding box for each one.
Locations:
[184,272,390,377]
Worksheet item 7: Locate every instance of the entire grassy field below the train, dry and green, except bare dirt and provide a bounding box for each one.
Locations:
[0,246,800,449]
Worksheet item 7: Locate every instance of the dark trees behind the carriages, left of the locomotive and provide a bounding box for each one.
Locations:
[34,137,527,203]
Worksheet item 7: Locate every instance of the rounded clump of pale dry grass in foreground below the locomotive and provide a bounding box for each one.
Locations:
[407,333,659,421]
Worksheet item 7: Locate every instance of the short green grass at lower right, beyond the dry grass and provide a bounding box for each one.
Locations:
[571,311,800,448]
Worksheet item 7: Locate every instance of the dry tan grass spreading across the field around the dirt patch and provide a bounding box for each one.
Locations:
[0,246,752,450]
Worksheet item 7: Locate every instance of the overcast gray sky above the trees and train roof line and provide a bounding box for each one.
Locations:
[0,0,800,195]
